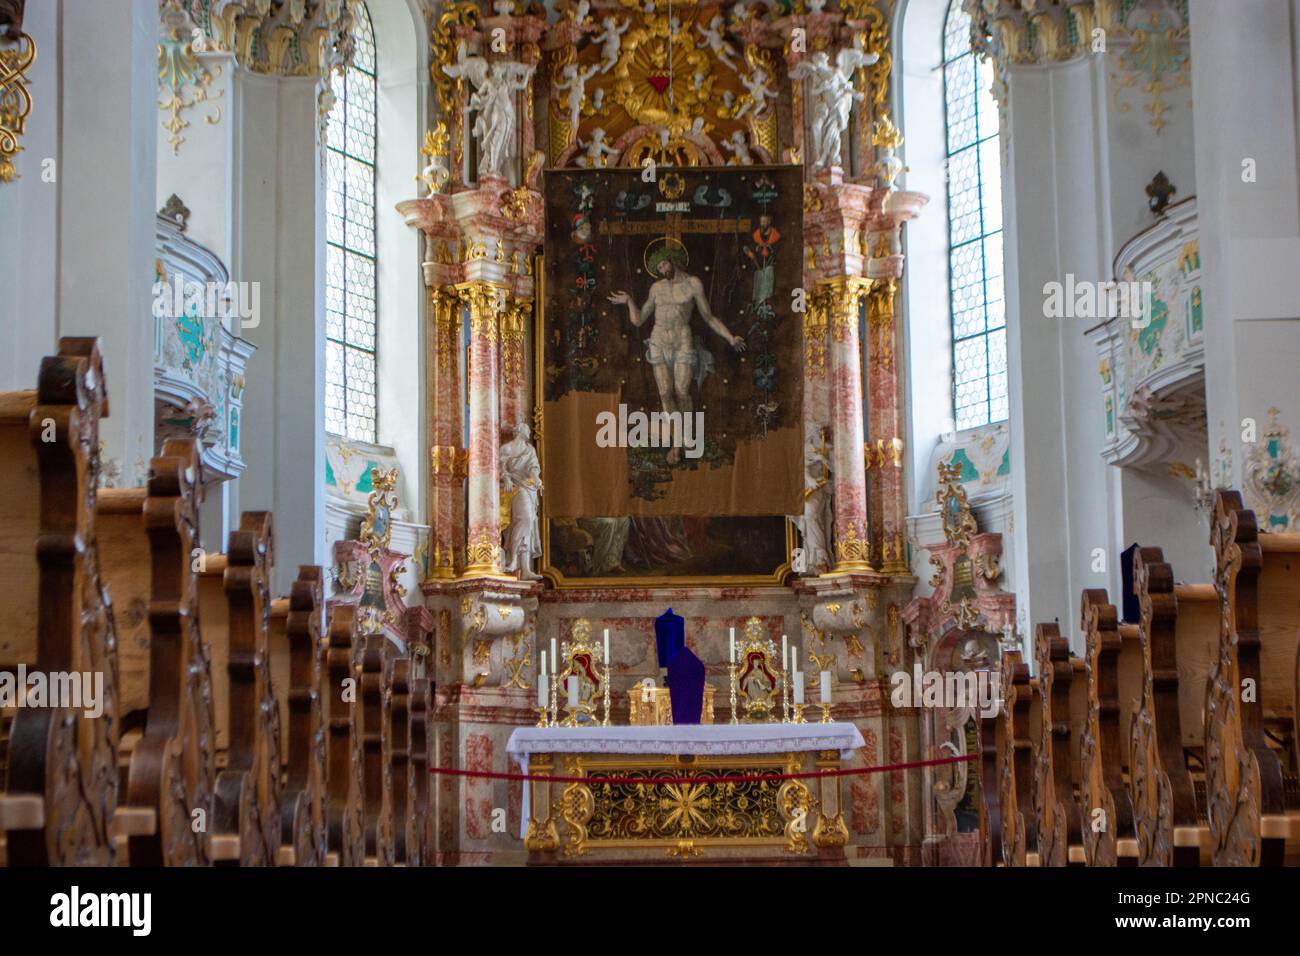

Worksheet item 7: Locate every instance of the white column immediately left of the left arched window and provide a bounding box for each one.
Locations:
[230,72,328,593]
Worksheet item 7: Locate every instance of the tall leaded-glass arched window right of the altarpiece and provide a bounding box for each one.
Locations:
[944,0,1008,429]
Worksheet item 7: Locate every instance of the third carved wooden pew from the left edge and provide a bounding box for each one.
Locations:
[199,511,281,866]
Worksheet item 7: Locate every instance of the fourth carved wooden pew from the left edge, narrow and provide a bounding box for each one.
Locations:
[272,564,329,866]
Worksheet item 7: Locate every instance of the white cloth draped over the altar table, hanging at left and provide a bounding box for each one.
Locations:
[506,722,866,838]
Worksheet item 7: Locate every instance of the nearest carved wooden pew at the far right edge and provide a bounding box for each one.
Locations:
[1205,490,1300,866]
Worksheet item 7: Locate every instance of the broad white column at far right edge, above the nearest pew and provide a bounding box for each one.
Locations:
[1191,0,1300,494]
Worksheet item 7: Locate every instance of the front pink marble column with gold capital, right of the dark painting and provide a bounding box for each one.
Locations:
[818,277,871,572]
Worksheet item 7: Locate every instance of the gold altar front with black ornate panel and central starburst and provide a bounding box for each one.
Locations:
[524,750,849,865]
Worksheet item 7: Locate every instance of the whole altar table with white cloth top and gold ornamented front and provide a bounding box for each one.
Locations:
[506,723,863,864]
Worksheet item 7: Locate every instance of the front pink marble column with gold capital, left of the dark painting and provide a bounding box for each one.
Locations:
[456,281,501,575]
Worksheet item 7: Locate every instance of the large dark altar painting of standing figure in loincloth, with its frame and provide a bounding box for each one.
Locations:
[536,166,803,585]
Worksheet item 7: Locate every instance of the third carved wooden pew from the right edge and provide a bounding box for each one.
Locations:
[1079,588,1138,866]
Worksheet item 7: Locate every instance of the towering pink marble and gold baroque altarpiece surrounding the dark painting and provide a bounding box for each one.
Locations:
[398,0,928,864]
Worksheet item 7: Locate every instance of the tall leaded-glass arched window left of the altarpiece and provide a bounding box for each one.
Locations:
[325,4,377,442]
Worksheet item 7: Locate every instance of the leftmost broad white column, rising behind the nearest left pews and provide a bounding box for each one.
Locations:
[44,0,159,485]
